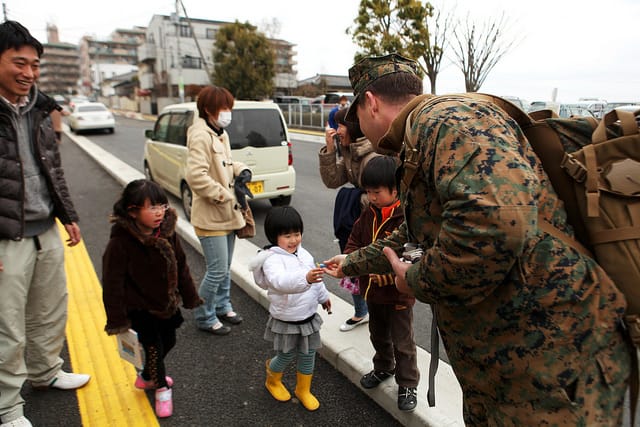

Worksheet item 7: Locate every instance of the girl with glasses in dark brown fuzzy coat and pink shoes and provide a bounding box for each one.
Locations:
[102,179,202,418]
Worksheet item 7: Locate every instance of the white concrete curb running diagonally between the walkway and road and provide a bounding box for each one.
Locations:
[86,117,464,427]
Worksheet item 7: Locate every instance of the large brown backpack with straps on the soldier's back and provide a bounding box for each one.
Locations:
[402,93,640,414]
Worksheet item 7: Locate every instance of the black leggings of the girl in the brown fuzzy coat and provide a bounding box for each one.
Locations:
[129,310,184,388]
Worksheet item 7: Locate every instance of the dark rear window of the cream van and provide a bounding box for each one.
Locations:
[226,109,287,150]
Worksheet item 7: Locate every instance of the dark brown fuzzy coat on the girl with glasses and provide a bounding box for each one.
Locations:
[102,209,202,335]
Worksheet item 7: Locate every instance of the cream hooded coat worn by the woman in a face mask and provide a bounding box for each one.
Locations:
[186,117,249,231]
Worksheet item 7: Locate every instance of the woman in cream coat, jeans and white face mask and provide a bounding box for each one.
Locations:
[186,86,251,335]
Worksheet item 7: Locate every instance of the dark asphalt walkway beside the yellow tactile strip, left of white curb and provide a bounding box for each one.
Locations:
[18,127,400,427]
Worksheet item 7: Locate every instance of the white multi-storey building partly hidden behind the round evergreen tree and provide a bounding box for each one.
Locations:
[138,14,297,100]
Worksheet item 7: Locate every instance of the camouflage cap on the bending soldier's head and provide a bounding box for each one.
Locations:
[345,53,418,122]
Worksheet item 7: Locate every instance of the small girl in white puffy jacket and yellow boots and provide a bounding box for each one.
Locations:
[249,206,331,411]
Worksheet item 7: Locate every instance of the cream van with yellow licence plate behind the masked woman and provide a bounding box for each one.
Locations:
[144,101,296,218]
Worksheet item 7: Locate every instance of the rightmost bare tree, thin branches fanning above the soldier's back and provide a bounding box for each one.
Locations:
[453,12,516,92]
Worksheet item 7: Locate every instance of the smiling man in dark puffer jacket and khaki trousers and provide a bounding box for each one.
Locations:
[0,21,90,427]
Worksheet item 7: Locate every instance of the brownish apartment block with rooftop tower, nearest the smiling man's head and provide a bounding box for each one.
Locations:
[38,24,80,95]
